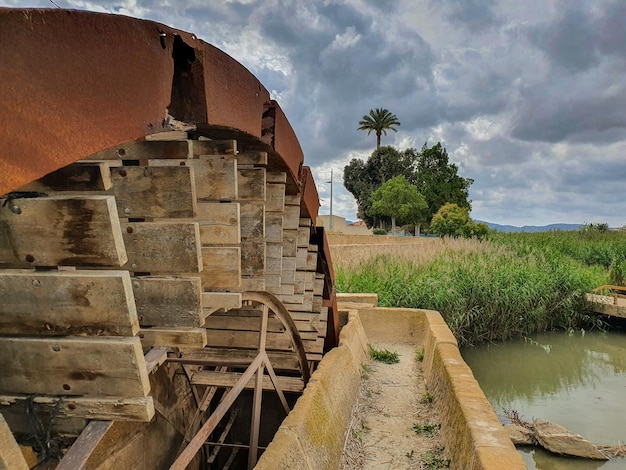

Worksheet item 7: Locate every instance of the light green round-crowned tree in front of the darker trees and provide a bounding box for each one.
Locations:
[372,175,428,233]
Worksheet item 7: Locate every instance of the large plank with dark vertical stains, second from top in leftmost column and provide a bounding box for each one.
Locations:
[0,195,127,267]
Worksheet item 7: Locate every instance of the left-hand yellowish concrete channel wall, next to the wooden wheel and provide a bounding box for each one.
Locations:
[255,313,367,470]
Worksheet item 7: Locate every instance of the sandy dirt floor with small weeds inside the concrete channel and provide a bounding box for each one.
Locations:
[340,343,447,470]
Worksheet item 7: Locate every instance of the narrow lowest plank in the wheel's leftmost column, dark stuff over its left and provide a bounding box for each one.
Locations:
[0,395,154,422]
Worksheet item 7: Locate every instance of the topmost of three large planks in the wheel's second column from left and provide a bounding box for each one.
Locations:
[111,166,196,217]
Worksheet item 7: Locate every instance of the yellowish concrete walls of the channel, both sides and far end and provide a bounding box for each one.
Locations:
[256,294,526,470]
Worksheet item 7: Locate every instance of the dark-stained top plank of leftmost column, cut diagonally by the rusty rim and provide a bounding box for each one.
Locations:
[20,161,112,193]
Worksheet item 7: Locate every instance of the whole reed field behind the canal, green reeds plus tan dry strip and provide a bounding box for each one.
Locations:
[330,232,626,346]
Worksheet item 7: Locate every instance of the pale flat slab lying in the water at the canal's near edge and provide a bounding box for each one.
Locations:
[533,420,609,460]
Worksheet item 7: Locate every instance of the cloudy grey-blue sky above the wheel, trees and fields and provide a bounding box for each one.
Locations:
[0,0,626,227]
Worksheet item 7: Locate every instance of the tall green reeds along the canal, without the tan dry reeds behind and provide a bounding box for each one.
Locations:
[336,234,607,345]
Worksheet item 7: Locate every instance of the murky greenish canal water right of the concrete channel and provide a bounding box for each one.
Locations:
[462,330,626,470]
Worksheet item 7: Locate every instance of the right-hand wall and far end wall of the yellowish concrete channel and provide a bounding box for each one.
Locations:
[352,300,526,470]
